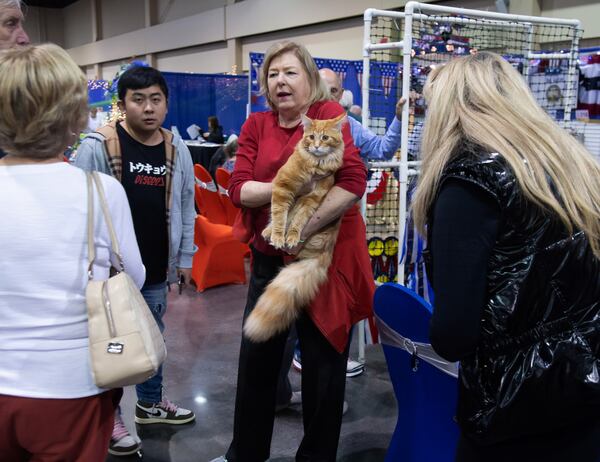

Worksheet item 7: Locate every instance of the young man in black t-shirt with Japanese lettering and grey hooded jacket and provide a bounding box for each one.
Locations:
[75,67,196,455]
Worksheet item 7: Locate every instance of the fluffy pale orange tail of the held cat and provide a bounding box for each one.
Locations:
[244,252,332,342]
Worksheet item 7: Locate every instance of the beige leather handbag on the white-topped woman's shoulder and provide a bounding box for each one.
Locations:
[85,172,167,388]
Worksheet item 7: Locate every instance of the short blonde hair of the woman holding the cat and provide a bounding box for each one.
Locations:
[260,40,331,110]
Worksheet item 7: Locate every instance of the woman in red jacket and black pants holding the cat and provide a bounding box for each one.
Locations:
[216,42,374,462]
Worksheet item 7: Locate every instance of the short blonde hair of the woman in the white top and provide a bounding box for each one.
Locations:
[0,44,88,159]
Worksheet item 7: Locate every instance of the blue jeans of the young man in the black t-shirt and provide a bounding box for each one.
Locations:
[135,282,167,403]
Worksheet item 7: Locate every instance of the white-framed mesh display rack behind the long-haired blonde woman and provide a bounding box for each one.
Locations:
[359,2,582,359]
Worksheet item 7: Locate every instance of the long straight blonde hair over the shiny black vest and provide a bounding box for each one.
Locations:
[412,52,600,258]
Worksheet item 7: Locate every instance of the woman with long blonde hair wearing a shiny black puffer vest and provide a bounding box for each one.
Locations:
[413,52,600,462]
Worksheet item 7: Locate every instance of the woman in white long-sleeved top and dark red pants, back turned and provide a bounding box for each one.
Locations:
[0,45,144,462]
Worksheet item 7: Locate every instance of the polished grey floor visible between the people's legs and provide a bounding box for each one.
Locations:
[107,274,396,462]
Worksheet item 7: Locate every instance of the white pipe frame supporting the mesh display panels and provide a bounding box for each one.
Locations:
[358,1,581,363]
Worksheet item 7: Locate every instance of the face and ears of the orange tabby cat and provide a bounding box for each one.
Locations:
[302,114,346,157]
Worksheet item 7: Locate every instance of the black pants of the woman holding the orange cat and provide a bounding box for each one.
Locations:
[226,250,348,462]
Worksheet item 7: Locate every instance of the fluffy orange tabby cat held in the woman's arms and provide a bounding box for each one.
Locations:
[244,114,346,342]
